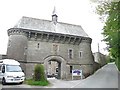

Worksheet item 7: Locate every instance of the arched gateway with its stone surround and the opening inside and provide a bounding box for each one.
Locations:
[44,56,66,79]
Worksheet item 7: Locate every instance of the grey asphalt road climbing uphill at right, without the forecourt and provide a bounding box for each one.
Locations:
[72,64,118,88]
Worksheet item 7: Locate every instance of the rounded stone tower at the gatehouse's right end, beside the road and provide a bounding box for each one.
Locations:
[80,38,94,77]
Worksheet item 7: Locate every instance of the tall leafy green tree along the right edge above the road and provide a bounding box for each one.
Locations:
[96,1,120,70]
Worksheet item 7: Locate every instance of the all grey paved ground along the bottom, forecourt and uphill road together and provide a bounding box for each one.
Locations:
[2,63,120,90]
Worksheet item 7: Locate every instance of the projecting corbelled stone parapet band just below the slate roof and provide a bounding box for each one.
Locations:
[8,28,92,45]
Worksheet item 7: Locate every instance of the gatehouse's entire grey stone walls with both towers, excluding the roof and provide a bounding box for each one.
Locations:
[7,28,94,79]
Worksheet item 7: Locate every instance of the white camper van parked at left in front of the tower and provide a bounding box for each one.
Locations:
[0,59,25,85]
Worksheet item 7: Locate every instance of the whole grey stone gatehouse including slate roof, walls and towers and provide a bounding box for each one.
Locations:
[7,12,94,79]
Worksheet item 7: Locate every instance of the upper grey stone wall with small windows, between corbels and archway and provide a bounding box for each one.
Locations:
[27,41,93,64]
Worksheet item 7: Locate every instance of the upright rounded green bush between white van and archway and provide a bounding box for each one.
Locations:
[34,64,47,81]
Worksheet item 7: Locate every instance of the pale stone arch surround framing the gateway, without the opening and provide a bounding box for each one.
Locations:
[44,56,66,79]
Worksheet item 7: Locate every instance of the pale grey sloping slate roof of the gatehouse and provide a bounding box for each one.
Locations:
[14,16,88,37]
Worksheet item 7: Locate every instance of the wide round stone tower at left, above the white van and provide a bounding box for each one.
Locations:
[7,28,28,61]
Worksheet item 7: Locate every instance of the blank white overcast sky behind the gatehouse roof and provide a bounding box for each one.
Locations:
[0,0,106,54]
